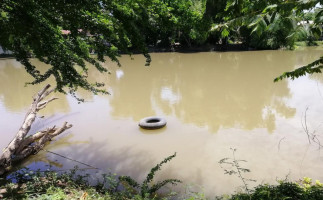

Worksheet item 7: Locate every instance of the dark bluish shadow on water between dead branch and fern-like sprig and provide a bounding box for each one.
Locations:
[21,138,182,186]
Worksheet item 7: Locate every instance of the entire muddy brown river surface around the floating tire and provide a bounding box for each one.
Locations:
[0,47,323,196]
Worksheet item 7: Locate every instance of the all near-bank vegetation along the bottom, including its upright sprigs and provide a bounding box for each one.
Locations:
[0,152,323,200]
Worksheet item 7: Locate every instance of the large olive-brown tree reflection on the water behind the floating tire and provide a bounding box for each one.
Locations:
[110,51,297,133]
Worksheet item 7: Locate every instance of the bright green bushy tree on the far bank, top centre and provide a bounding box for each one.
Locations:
[143,0,207,47]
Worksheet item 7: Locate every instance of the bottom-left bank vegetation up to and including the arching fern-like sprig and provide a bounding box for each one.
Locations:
[0,153,181,200]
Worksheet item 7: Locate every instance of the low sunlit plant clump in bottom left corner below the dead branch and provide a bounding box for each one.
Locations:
[0,168,112,200]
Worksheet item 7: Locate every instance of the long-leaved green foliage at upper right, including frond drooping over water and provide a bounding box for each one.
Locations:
[205,0,323,81]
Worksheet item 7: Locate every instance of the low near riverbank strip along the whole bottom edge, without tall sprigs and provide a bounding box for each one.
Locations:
[0,169,323,200]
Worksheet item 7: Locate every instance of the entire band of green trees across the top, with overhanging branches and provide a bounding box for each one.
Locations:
[0,0,323,94]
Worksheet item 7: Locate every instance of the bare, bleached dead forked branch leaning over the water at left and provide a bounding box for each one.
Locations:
[0,84,72,176]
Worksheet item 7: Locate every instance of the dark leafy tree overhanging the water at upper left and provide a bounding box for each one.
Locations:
[0,0,149,97]
